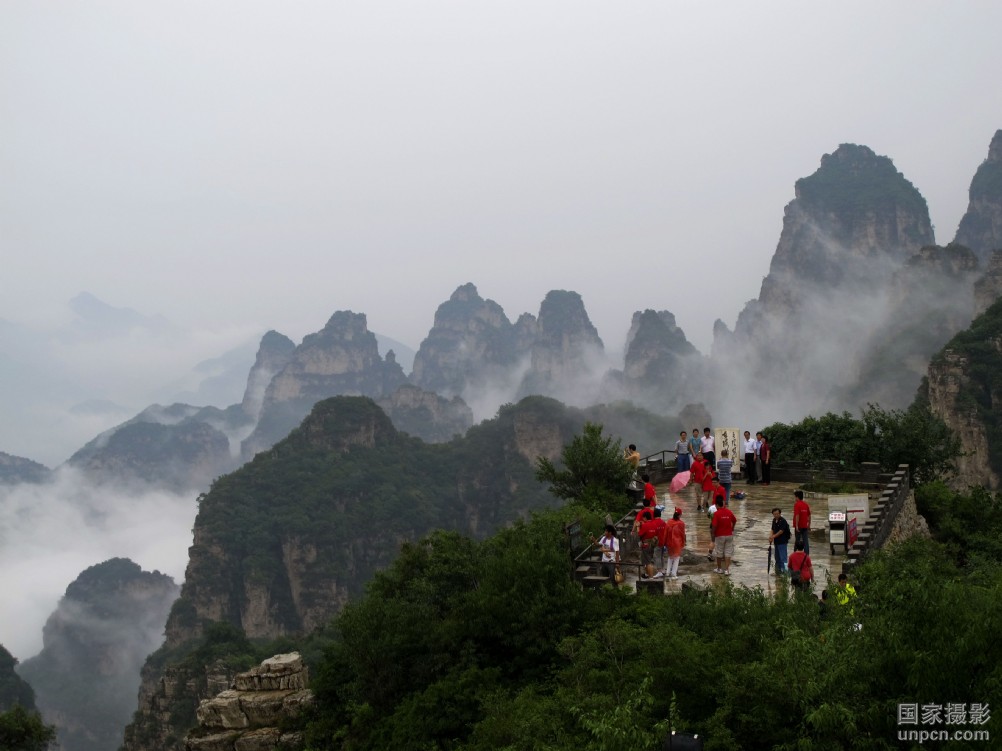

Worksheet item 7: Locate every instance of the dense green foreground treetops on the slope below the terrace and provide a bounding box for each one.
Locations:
[300,450,1002,751]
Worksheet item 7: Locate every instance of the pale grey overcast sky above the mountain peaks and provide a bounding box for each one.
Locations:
[0,0,1002,466]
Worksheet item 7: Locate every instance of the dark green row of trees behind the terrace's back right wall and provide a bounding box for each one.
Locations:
[764,399,960,483]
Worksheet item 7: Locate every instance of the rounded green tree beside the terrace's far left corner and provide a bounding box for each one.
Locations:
[536,423,633,510]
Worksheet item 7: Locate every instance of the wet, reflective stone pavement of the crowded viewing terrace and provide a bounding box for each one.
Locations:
[623,480,845,595]
